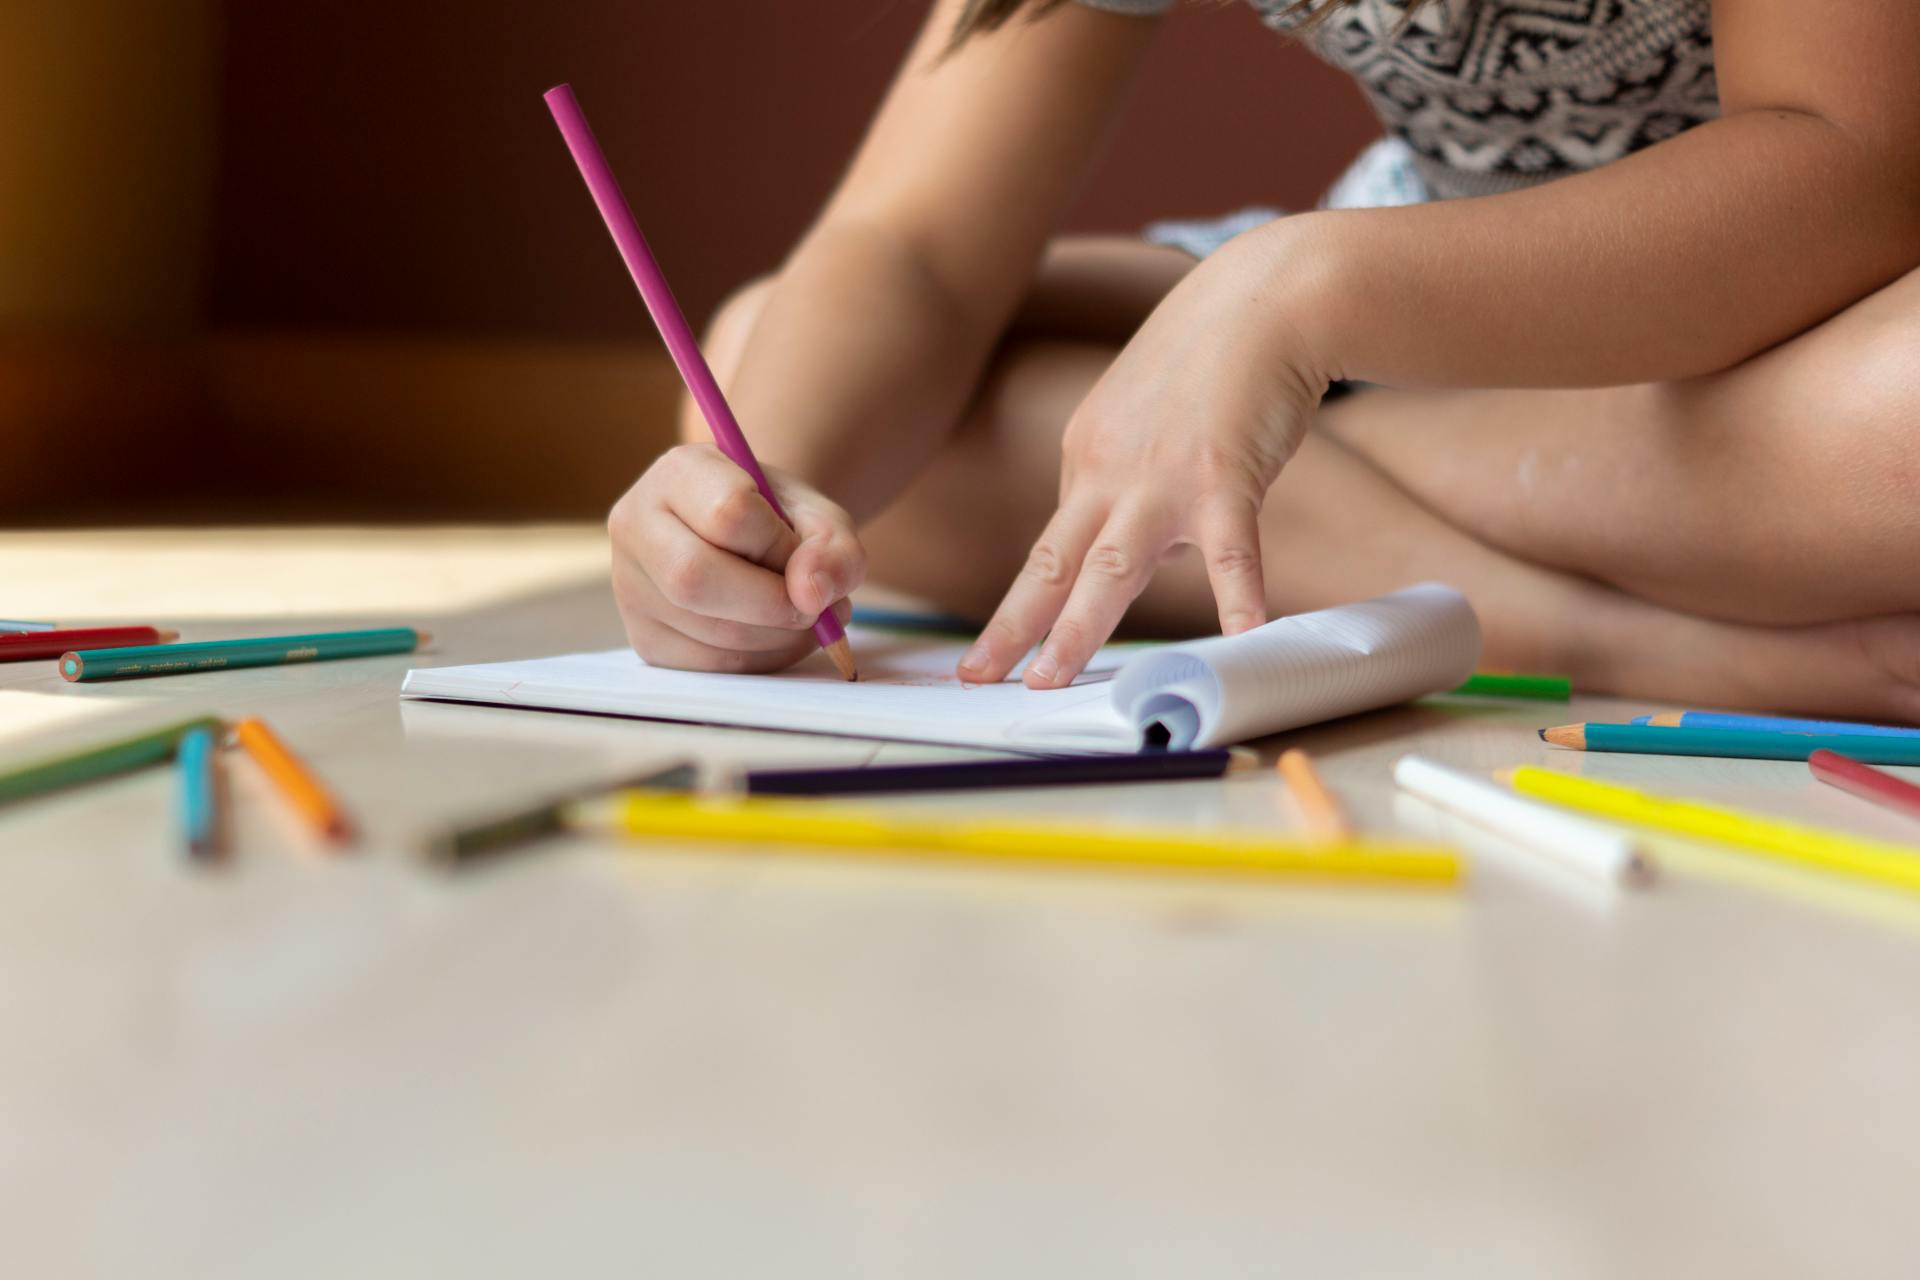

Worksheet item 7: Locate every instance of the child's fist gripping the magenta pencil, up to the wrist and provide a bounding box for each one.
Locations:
[607,445,866,672]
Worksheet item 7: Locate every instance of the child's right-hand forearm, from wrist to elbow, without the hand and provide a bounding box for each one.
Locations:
[1259,111,1920,388]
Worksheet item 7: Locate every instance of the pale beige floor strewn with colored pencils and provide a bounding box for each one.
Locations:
[0,528,1920,1278]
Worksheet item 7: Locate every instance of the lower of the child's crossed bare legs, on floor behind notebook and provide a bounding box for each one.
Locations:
[866,342,1920,720]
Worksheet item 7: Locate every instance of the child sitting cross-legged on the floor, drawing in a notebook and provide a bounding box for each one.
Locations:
[611,0,1920,720]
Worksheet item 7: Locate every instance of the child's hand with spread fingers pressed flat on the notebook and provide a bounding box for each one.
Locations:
[960,238,1327,689]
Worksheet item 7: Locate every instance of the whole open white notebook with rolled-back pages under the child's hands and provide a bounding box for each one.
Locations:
[401,583,1480,754]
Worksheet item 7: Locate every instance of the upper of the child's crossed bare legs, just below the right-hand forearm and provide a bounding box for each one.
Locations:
[1323,264,1920,622]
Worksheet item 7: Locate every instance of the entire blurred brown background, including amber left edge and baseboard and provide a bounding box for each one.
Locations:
[0,0,1375,526]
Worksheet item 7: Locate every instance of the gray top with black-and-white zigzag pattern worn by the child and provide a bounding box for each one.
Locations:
[1081,0,1720,203]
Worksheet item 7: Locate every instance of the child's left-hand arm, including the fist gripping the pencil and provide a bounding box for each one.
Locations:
[609,0,1156,672]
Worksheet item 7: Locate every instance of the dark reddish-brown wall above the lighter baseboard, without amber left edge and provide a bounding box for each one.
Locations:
[213,0,1373,338]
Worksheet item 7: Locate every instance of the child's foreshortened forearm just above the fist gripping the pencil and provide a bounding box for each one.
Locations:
[728,223,1021,520]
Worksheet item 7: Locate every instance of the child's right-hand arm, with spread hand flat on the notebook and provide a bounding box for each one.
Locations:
[964,0,1920,687]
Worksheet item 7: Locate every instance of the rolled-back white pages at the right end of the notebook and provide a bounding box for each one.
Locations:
[1112,581,1480,750]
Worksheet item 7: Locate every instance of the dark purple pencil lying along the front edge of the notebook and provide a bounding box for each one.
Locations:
[741,750,1235,796]
